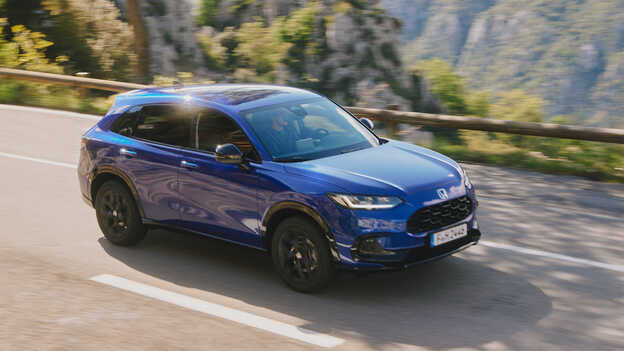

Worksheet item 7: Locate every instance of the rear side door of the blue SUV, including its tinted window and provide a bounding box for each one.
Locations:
[112,104,192,225]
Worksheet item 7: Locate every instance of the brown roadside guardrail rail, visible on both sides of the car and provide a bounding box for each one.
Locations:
[0,68,624,144]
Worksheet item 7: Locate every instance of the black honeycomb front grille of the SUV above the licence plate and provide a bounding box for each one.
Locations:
[407,196,472,233]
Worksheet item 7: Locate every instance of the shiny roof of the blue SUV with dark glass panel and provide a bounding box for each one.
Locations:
[119,84,320,112]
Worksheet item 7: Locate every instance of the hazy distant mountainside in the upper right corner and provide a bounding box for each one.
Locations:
[382,0,624,127]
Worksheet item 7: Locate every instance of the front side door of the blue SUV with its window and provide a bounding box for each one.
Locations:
[179,108,262,247]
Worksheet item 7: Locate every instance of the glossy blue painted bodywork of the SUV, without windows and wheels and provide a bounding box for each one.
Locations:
[78,85,478,269]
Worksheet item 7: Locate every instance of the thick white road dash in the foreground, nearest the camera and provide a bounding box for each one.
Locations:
[90,274,345,348]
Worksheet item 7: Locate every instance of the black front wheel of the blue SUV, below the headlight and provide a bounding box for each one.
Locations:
[271,217,335,293]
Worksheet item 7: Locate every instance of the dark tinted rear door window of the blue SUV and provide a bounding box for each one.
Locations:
[134,105,192,147]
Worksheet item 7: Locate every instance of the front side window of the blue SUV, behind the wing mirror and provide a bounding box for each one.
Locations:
[195,109,254,158]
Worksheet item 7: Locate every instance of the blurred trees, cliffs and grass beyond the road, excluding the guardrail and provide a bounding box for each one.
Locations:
[0,0,624,182]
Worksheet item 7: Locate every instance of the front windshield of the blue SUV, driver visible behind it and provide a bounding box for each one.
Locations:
[241,98,379,162]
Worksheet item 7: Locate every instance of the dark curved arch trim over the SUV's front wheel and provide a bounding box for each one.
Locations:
[261,201,340,263]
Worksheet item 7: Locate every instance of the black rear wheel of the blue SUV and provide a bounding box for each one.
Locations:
[95,180,147,246]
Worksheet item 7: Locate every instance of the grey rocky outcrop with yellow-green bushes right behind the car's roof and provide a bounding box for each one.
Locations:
[119,0,437,110]
